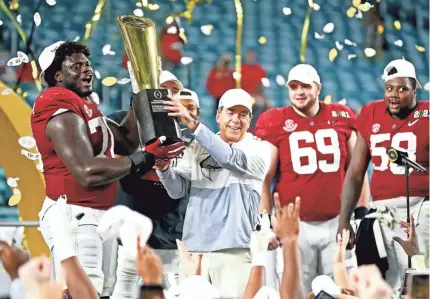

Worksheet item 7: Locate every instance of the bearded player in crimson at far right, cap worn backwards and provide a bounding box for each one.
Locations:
[339,59,430,289]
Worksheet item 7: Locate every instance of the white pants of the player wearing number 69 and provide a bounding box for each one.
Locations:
[276,216,357,294]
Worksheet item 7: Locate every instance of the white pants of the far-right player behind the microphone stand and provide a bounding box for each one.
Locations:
[372,197,430,290]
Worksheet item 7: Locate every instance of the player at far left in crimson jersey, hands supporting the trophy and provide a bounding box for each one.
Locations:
[31,41,183,296]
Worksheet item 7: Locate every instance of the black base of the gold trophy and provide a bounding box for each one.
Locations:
[132,89,182,146]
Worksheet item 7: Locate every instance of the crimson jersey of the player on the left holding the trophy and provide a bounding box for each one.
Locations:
[31,87,118,210]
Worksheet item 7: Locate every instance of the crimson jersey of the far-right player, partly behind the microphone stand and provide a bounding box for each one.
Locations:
[358,100,430,200]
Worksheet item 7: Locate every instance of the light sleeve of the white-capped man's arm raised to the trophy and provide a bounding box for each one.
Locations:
[194,124,270,179]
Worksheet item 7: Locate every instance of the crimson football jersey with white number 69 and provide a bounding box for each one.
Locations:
[255,102,356,221]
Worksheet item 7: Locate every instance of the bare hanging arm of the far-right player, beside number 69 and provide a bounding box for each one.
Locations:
[338,133,370,249]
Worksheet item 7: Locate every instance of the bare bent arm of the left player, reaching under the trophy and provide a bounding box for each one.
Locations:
[46,112,155,187]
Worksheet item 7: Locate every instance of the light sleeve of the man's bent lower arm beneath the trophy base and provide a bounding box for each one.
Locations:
[156,147,192,199]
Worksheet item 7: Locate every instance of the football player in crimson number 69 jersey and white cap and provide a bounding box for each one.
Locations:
[255,64,368,292]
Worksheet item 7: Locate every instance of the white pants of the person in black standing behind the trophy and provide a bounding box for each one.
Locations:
[111,246,182,299]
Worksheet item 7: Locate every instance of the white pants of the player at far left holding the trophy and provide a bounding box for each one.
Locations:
[39,198,118,296]
